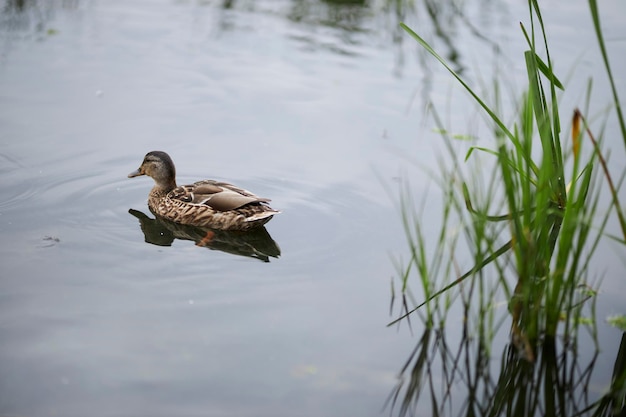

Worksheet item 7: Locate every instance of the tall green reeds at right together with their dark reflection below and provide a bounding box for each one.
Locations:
[389,0,626,415]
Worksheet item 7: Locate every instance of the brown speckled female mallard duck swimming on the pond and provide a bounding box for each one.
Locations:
[128,151,280,230]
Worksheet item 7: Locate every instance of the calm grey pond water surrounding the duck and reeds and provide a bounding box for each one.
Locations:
[0,0,626,416]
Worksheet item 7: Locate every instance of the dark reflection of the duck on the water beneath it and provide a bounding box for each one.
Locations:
[128,209,280,262]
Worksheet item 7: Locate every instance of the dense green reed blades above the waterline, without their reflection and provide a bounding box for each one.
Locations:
[393,1,598,340]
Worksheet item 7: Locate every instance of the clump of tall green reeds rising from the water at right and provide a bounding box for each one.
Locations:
[390,1,603,347]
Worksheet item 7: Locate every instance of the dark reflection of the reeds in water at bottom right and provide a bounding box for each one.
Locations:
[387,310,626,416]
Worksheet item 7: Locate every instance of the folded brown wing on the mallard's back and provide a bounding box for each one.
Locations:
[178,180,270,211]
